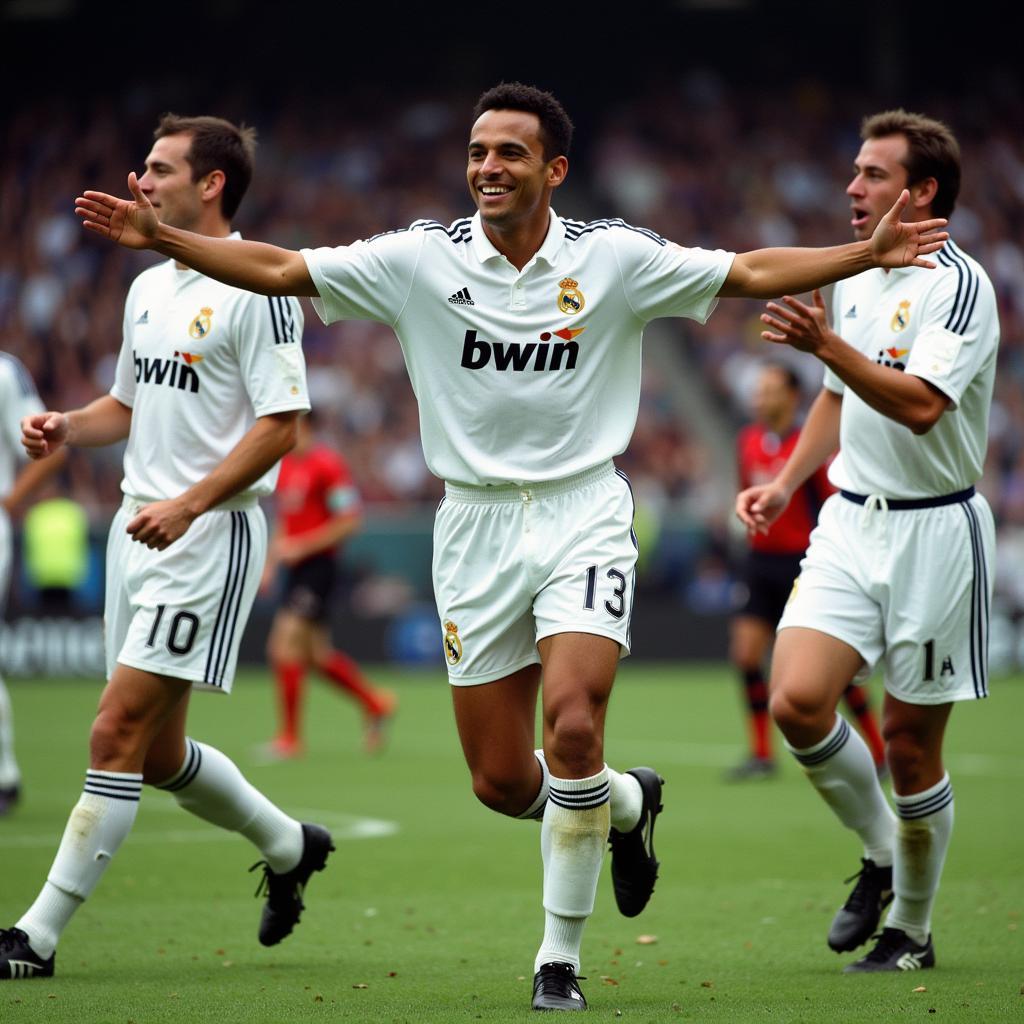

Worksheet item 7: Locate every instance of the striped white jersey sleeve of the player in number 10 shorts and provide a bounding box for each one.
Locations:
[234,292,309,417]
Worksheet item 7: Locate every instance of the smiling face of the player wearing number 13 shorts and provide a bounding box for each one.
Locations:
[466,111,568,232]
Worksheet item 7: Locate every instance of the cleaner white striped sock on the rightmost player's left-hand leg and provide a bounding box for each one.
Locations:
[785,715,896,867]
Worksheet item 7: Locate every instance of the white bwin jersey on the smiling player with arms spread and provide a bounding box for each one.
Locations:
[302,212,733,485]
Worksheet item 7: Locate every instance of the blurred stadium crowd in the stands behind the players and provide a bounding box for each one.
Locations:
[0,73,1024,630]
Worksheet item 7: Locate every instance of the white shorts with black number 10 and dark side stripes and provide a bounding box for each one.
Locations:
[104,498,266,693]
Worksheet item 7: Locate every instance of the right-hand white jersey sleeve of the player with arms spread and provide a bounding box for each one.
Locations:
[614,225,735,324]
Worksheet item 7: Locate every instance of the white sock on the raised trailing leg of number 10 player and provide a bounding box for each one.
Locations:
[158,738,303,873]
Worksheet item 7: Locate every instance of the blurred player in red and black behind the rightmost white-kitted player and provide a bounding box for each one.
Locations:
[726,364,885,781]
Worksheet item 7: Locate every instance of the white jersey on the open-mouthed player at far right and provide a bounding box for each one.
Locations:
[824,241,999,498]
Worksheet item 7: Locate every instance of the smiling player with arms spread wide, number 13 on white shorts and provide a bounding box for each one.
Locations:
[77,83,944,1010]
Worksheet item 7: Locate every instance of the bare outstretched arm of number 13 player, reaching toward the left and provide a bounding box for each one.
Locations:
[75,171,315,296]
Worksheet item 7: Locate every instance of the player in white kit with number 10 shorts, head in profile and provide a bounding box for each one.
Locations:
[0,115,333,979]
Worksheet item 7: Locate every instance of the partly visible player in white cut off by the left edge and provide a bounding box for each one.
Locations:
[0,352,65,815]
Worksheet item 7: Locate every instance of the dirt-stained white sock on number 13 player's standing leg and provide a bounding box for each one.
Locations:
[534,768,610,972]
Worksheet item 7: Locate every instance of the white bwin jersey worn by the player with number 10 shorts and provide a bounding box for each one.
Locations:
[111,243,309,503]
